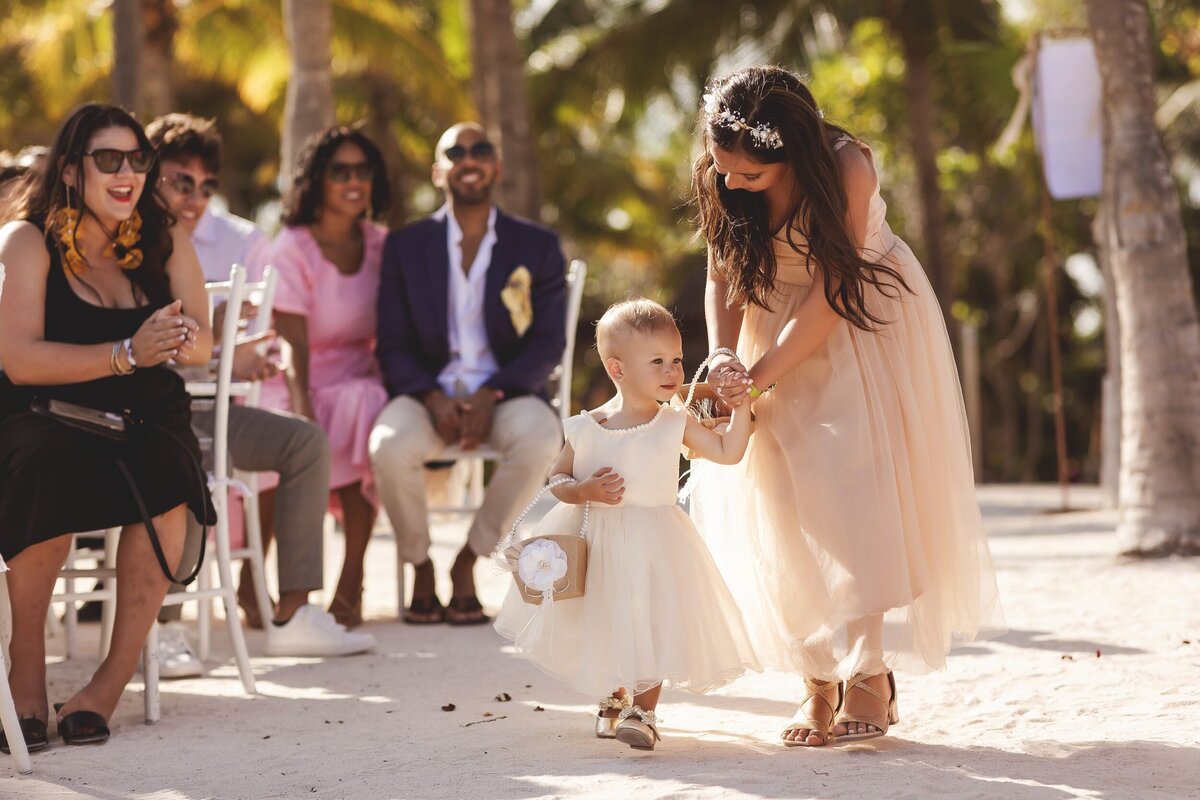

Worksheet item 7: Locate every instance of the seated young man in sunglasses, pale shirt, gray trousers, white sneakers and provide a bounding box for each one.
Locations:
[146,114,374,678]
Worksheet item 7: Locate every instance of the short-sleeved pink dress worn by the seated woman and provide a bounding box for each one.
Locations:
[262,221,388,503]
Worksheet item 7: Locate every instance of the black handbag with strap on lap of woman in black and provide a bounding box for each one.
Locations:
[29,398,209,587]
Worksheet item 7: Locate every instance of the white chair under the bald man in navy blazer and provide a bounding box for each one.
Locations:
[396,259,588,614]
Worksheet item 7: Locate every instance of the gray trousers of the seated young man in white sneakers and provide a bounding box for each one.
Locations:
[160,405,329,621]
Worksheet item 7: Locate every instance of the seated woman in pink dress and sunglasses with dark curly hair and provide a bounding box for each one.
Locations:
[263,127,388,627]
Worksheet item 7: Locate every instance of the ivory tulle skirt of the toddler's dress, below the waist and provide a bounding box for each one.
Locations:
[496,505,758,697]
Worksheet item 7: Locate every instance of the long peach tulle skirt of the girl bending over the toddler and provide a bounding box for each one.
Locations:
[691,240,1003,680]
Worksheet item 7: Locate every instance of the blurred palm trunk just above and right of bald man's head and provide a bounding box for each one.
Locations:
[470,0,541,219]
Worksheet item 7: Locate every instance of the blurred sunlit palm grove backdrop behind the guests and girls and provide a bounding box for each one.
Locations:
[0,0,1200,482]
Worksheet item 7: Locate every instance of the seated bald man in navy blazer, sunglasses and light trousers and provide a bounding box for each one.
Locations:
[371,122,566,625]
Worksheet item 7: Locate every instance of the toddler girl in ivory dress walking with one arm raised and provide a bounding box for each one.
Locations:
[496,299,760,750]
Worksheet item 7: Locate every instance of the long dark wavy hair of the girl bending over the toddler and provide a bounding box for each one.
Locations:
[692,66,908,330]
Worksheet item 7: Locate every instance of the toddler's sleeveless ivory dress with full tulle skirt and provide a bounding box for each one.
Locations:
[496,405,760,694]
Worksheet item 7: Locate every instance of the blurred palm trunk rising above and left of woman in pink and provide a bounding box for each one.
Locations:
[280,0,334,191]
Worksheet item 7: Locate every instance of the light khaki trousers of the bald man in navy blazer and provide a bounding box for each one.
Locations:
[370,397,563,564]
